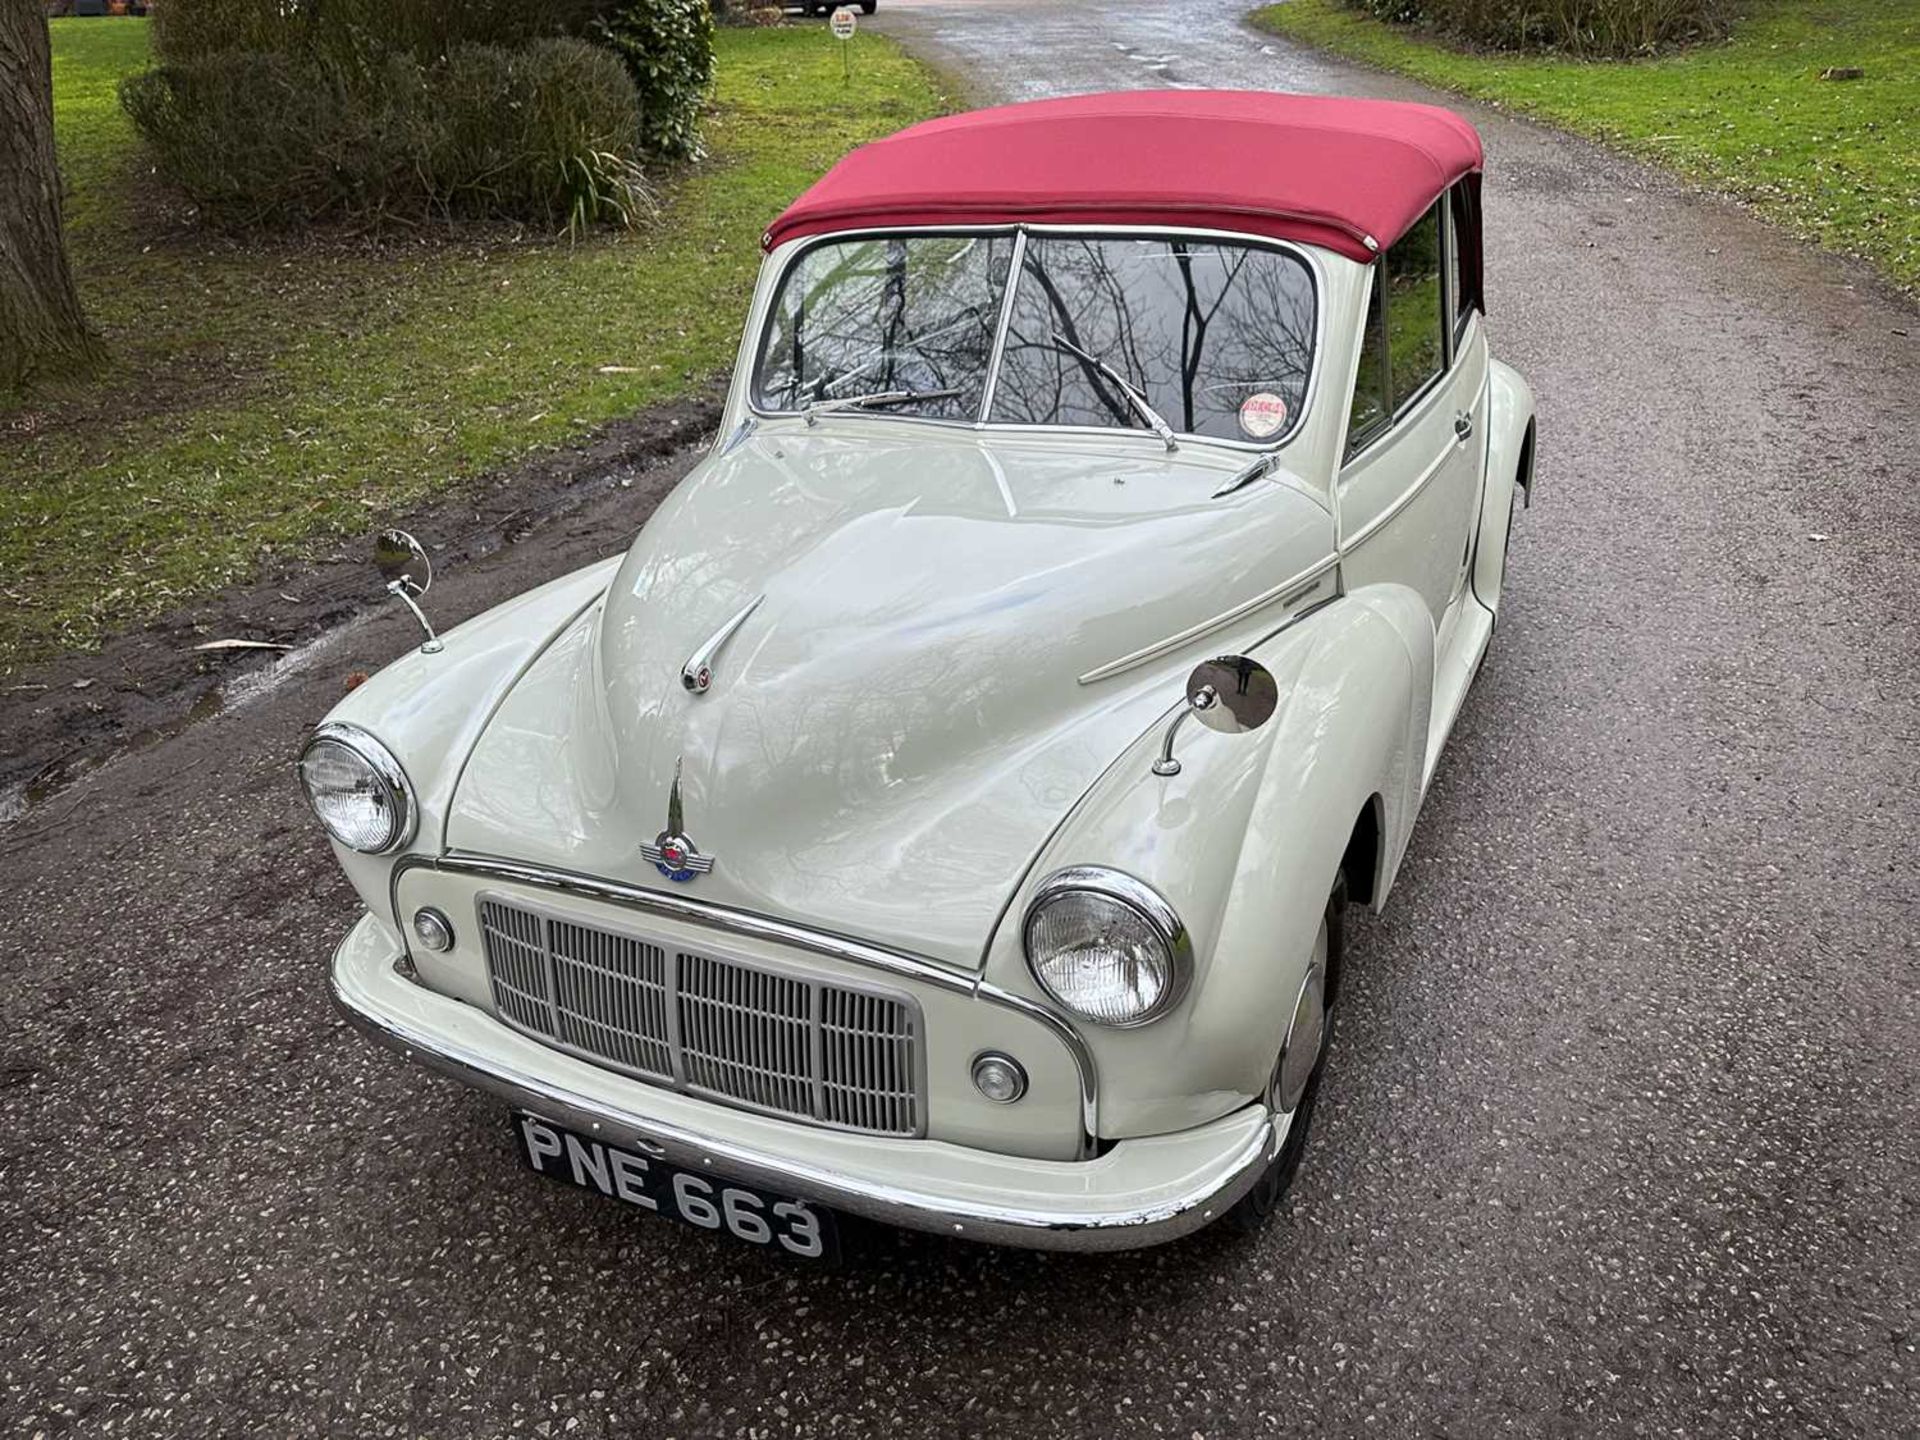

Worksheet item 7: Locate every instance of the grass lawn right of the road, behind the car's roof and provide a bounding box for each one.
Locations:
[1254,0,1920,292]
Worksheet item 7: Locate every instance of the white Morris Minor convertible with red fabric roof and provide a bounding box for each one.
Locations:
[300,92,1534,1258]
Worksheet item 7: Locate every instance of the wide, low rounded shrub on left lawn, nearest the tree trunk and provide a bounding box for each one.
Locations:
[121,38,647,230]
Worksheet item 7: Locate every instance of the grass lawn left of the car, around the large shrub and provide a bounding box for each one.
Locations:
[0,19,943,674]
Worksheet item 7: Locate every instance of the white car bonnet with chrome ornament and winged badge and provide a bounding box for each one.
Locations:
[447,428,1332,970]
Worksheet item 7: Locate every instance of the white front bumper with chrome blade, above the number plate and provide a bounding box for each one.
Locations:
[332,914,1284,1250]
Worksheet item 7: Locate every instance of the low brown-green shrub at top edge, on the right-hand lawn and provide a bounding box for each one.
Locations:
[1346,0,1732,56]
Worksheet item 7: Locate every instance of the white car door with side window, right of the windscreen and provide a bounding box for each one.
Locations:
[1336,196,1486,634]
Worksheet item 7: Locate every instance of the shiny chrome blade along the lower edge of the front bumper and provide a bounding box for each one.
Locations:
[330,948,1284,1250]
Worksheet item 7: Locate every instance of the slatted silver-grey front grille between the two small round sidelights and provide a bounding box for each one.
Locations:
[480,899,922,1135]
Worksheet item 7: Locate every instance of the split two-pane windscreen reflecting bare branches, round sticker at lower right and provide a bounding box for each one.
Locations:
[755,234,1315,444]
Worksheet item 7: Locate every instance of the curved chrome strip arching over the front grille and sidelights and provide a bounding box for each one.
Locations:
[388,851,1100,1158]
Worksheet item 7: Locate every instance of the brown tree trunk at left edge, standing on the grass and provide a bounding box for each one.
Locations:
[0,0,104,392]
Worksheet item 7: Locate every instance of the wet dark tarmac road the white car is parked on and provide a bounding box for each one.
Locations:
[0,0,1920,1438]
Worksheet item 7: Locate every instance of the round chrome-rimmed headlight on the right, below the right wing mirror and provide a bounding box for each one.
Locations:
[1025,866,1192,1029]
